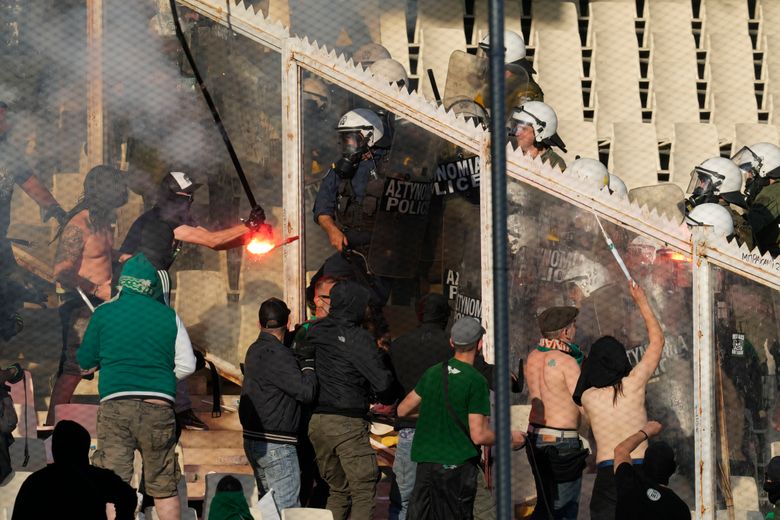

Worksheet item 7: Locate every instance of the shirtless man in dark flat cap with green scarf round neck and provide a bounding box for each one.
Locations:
[525,307,588,520]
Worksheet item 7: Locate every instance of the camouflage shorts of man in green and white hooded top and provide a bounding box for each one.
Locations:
[92,399,181,498]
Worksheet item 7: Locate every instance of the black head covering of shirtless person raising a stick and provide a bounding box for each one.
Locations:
[572,336,631,406]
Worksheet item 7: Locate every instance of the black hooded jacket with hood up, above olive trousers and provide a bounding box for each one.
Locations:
[306,280,395,417]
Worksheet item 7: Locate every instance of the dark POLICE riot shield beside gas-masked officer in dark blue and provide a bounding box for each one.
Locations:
[368,121,436,278]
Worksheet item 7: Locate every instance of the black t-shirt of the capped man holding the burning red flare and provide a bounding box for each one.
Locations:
[119,206,196,271]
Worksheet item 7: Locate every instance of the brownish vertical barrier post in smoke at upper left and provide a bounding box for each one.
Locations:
[86,0,105,169]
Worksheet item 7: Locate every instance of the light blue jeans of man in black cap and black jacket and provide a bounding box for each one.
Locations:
[244,439,301,511]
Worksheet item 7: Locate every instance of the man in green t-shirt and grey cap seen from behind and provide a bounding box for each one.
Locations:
[398,317,525,520]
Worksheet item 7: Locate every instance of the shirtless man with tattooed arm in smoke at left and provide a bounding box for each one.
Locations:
[46,165,127,425]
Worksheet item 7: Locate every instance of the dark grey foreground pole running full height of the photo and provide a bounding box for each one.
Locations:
[488,0,514,520]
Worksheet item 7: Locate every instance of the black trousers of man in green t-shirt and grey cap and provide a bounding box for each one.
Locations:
[407,462,479,520]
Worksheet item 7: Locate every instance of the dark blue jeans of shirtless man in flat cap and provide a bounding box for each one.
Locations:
[526,433,582,520]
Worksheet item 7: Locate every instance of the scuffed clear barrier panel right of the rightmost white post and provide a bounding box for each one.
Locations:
[711,268,780,511]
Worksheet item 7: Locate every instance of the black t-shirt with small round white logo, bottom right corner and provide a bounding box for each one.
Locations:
[615,462,691,520]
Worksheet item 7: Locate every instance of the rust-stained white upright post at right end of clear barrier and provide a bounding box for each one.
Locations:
[691,227,717,520]
